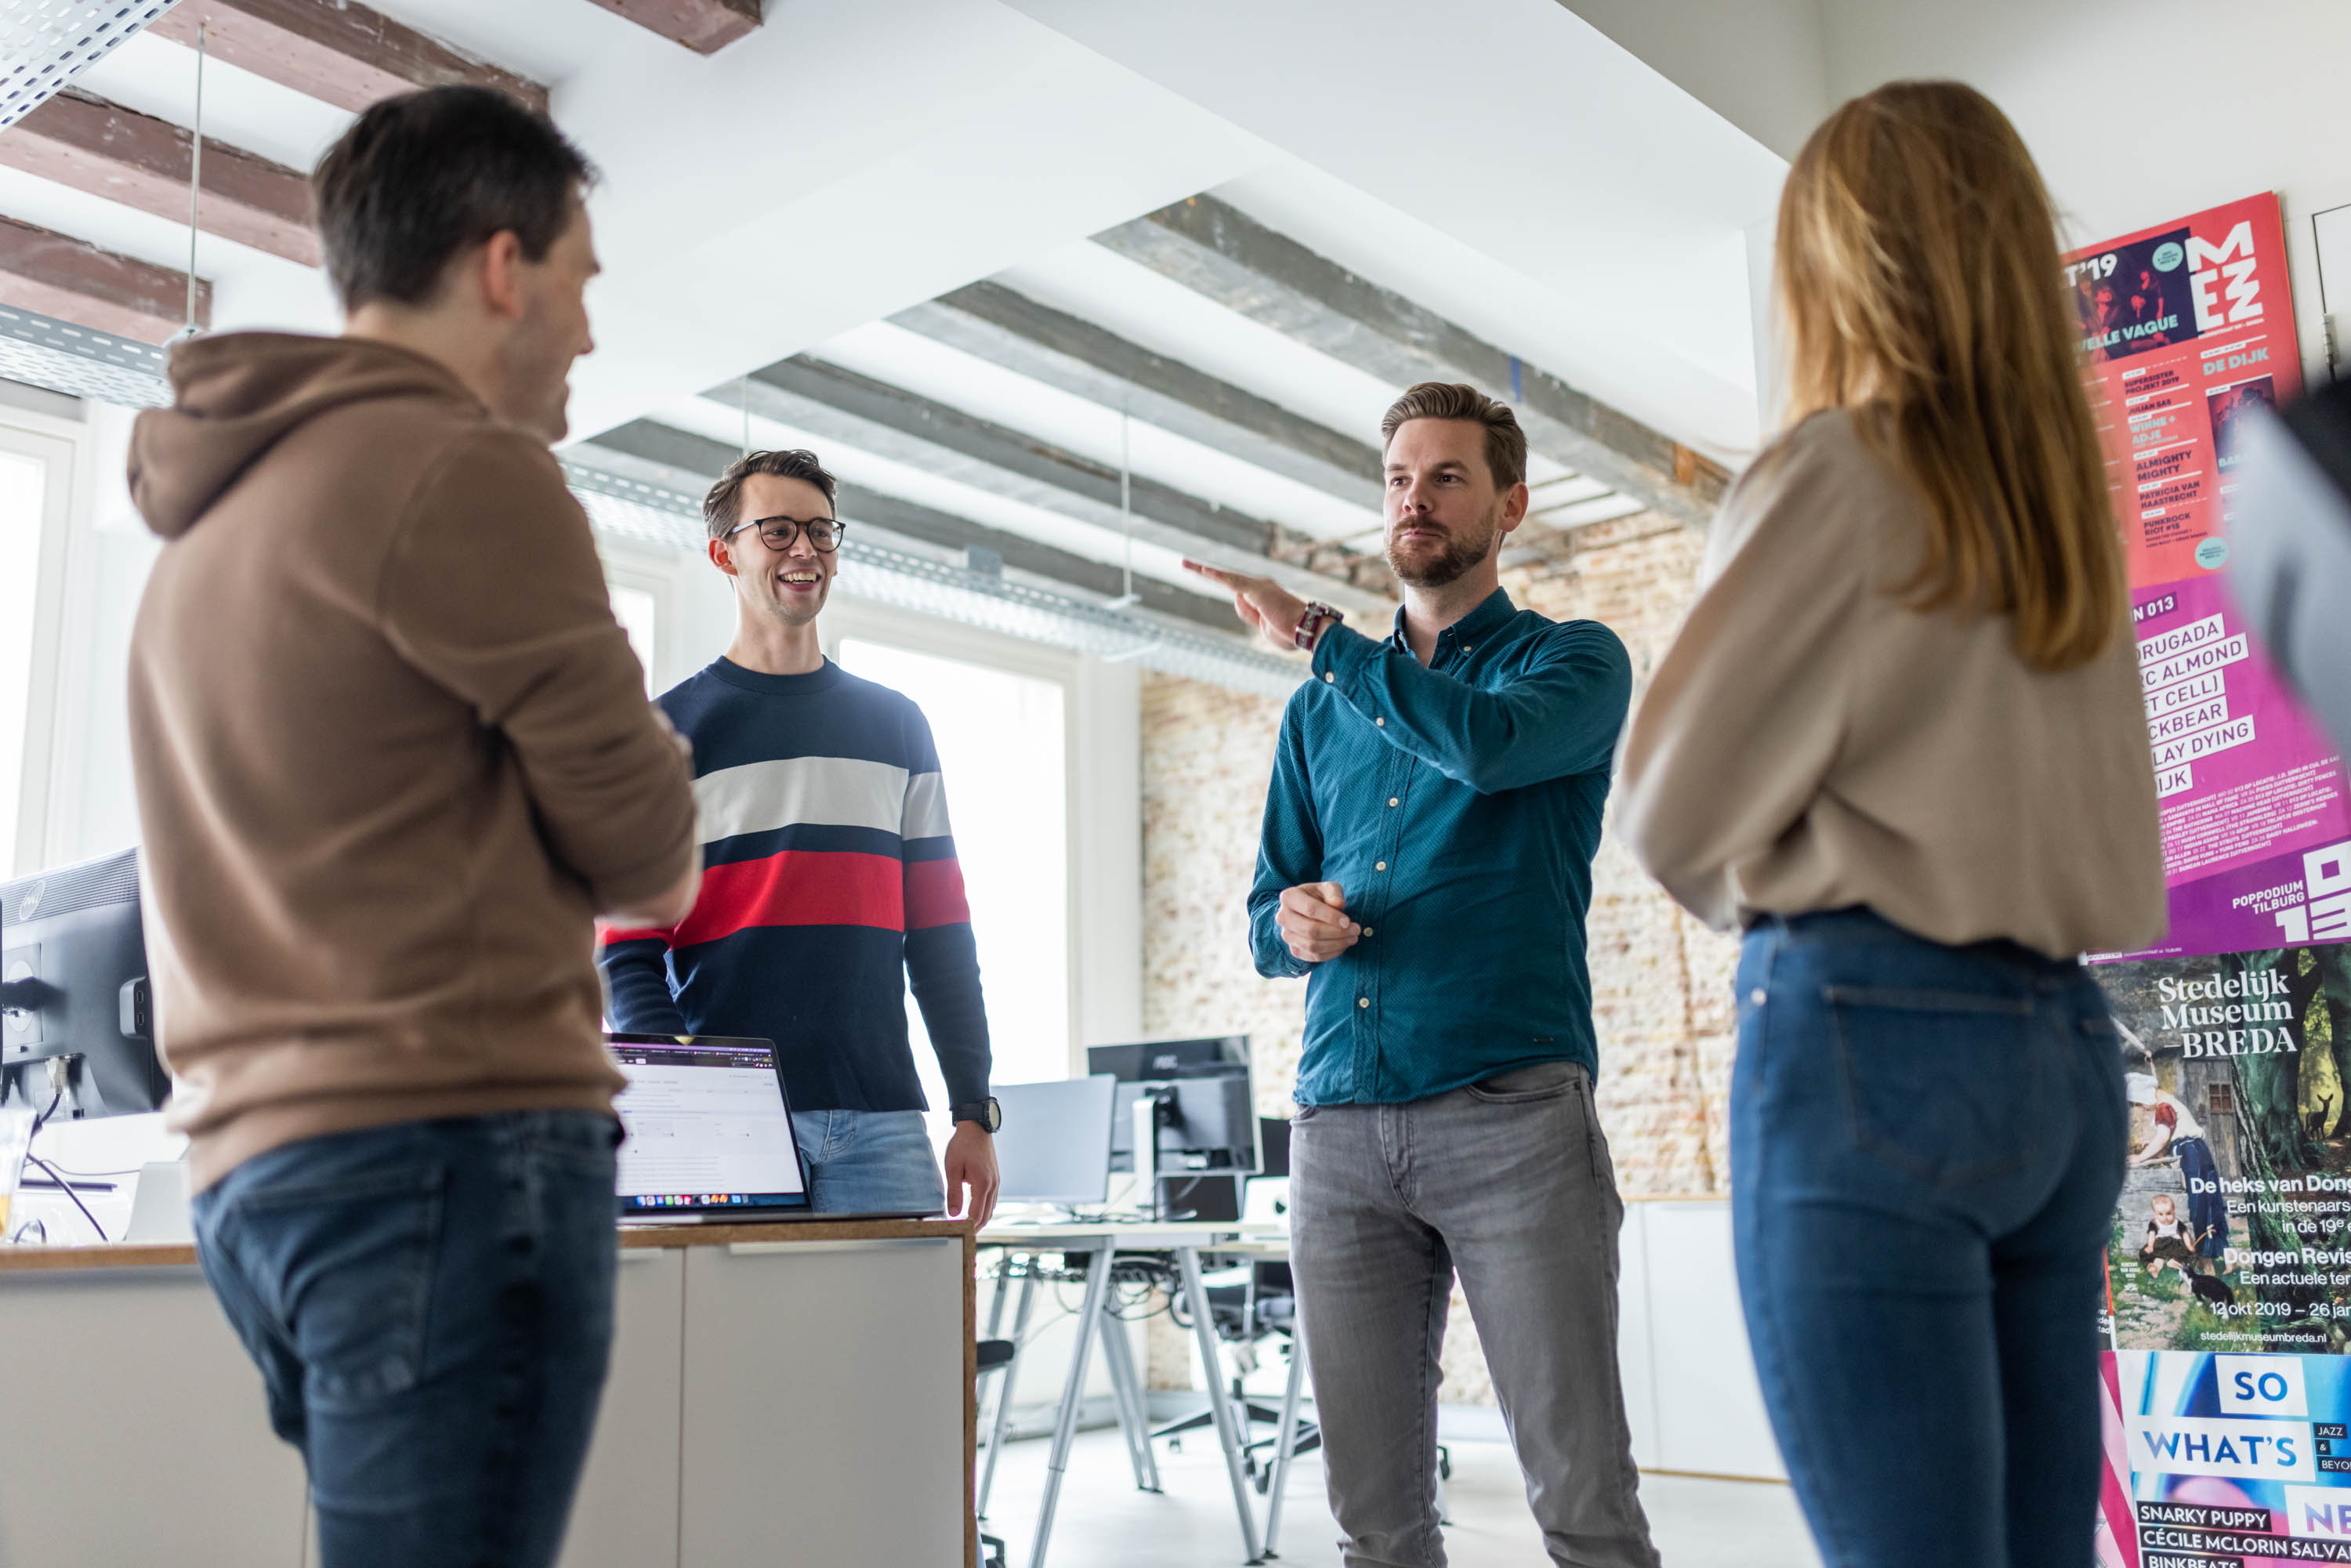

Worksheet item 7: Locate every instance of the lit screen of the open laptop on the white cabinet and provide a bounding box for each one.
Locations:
[607,1034,809,1215]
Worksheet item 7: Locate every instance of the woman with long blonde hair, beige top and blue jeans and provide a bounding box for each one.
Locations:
[1620,82,2163,1568]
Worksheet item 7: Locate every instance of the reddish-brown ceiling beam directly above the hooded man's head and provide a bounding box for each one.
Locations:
[148,0,548,113]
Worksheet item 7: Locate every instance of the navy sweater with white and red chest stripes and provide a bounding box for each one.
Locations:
[597,658,987,1110]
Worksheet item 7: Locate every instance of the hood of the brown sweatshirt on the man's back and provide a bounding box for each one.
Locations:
[129,331,482,538]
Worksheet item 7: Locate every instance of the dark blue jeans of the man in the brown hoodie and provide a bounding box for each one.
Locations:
[193,1112,618,1568]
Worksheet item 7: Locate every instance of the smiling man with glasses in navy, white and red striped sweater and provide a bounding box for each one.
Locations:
[600,451,997,1222]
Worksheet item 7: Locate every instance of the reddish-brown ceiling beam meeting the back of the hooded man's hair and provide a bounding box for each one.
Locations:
[0,89,317,266]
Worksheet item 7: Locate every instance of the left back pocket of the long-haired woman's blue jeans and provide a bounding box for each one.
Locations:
[1822,985,2041,1187]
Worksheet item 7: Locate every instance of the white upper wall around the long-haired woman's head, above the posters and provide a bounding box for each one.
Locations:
[1561,0,2351,404]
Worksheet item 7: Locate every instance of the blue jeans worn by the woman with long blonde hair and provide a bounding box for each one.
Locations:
[1730,910,2125,1568]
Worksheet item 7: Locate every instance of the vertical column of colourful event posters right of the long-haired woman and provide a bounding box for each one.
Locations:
[2067,195,2351,1568]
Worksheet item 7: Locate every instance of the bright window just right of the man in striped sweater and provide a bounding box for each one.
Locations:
[839,639,1070,1091]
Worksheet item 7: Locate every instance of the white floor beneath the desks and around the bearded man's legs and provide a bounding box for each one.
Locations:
[983,1429,1820,1568]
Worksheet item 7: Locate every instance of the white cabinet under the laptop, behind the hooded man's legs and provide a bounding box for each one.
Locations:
[0,1220,976,1568]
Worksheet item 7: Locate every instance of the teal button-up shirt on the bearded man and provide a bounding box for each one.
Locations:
[1248,590,1632,1105]
